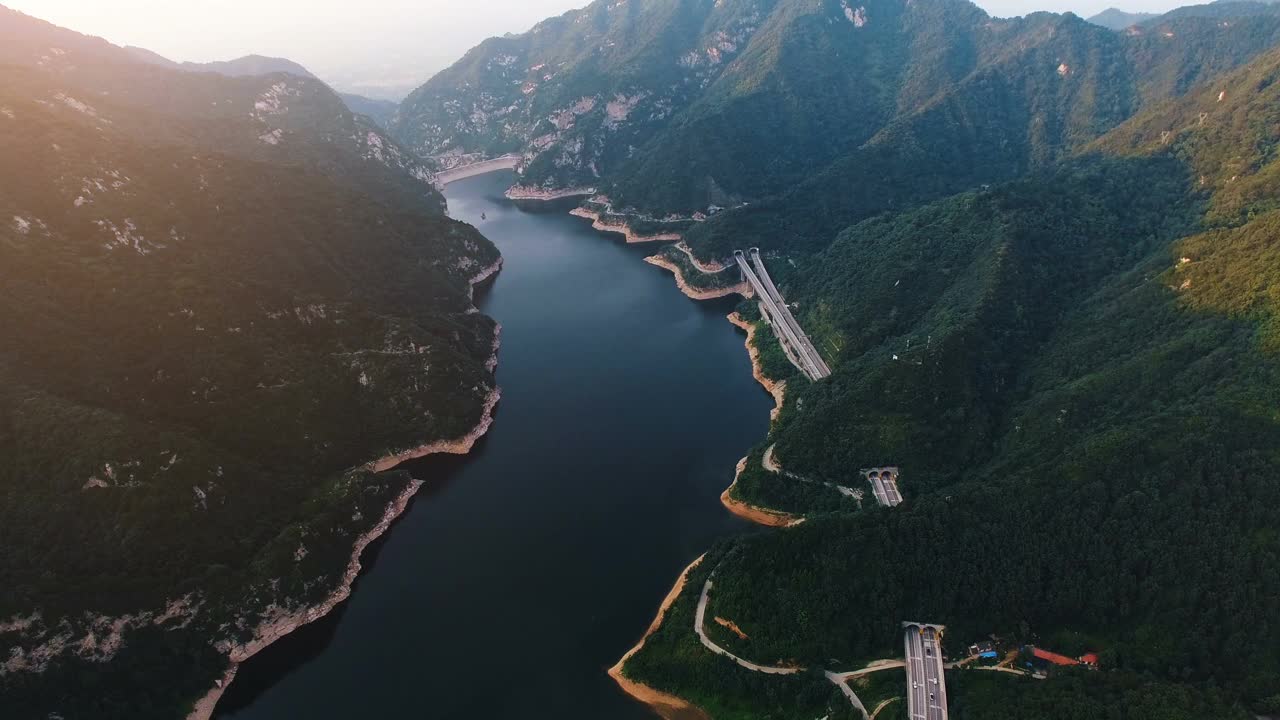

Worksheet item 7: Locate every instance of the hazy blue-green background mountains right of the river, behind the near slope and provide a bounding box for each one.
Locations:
[392,0,1280,213]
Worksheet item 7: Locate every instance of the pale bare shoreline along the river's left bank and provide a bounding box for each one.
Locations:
[186,256,502,720]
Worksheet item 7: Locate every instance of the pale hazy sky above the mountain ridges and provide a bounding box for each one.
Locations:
[10,0,1196,99]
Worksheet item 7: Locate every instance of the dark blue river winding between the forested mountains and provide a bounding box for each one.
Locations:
[216,172,772,720]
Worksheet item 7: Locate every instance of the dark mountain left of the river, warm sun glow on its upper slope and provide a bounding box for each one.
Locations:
[0,9,498,719]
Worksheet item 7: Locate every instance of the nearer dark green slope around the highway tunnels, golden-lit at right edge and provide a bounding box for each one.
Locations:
[606,18,1280,720]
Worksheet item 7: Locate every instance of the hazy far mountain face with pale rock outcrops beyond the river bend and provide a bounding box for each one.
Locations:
[393,0,776,179]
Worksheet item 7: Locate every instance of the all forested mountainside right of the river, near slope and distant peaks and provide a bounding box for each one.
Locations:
[394,0,1280,720]
